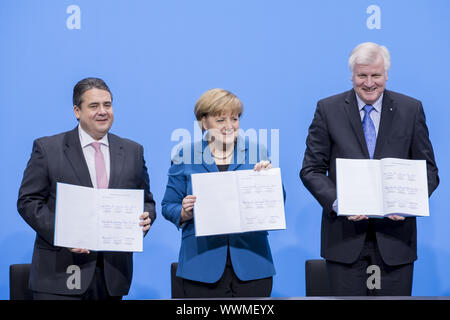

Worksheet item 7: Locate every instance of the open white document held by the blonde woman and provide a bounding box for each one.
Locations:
[191,168,286,236]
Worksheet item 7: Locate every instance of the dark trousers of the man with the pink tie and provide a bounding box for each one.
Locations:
[33,252,122,300]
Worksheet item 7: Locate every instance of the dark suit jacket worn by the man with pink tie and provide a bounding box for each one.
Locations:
[17,128,156,296]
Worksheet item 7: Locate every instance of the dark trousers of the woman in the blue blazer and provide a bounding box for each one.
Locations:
[183,248,273,298]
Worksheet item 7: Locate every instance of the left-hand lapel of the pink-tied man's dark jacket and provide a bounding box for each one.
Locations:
[64,127,93,188]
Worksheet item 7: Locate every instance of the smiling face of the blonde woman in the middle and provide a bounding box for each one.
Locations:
[202,111,239,145]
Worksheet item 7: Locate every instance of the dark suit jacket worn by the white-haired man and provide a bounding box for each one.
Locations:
[300,90,439,265]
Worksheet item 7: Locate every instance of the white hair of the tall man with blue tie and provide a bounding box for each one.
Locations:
[348,42,391,73]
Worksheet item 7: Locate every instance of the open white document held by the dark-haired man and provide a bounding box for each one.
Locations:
[54,183,144,252]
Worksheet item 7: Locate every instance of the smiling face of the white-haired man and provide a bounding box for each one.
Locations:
[352,55,388,104]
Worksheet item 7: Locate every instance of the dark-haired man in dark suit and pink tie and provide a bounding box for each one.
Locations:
[17,78,156,300]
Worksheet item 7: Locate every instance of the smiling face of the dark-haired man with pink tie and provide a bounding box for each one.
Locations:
[73,88,114,140]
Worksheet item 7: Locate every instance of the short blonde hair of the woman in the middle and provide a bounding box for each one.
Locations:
[194,88,244,127]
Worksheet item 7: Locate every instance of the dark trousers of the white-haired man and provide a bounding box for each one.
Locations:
[326,235,414,296]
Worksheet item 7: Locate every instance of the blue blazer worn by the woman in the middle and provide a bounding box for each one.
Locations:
[162,137,275,283]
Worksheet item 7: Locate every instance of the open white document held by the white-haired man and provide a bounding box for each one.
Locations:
[336,158,430,217]
